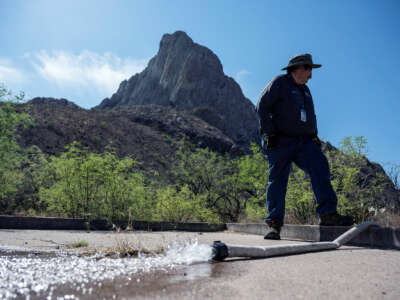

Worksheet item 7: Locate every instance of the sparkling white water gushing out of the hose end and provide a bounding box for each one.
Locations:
[0,240,212,299]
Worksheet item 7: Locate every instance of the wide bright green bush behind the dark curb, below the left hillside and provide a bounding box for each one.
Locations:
[40,142,145,221]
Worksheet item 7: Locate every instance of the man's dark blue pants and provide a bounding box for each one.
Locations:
[265,138,337,226]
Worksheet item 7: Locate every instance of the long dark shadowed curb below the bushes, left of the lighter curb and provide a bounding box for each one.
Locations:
[0,215,226,232]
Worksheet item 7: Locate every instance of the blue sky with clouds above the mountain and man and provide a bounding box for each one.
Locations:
[0,0,400,171]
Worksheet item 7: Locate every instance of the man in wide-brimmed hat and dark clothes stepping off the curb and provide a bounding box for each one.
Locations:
[256,54,354,240]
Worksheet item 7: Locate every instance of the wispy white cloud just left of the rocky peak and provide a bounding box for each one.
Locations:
[25,50,147,94]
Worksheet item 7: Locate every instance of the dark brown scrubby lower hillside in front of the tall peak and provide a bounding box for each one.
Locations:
[20,98,235,171]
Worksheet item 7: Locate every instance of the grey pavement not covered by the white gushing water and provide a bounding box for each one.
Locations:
[0,230,400,300]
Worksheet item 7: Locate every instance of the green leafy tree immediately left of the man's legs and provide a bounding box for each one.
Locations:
[170,142,268,222]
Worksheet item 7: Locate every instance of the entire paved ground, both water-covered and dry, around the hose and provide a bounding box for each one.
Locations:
[0,230,400,299]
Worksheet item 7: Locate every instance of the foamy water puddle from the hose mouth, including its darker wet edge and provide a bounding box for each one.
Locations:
[0,240,213,299]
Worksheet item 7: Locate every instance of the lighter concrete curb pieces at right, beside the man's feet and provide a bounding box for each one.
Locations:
[226,223,400,249]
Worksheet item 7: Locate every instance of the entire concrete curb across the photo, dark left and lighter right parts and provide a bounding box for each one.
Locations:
[0,215,400,249]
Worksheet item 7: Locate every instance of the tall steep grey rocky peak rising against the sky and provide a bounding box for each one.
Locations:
[95,31,258,148]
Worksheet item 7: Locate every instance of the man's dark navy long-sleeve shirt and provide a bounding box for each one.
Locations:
[256,74,318,137]
